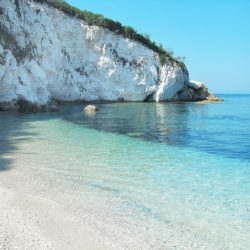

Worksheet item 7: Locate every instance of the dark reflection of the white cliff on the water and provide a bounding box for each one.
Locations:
[60,102,189,146]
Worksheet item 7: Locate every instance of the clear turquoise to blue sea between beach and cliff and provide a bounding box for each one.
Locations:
[0,95,250,250]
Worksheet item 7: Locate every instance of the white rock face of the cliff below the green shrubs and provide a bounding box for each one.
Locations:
[0,0,219,109]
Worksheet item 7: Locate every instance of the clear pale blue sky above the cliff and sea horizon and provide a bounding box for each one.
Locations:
[67,0,250,93]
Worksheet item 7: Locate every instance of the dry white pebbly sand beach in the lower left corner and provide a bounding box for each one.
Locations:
[0,170,106,250]
